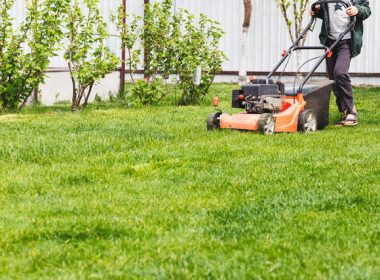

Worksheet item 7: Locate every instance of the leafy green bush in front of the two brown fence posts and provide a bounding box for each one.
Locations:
[114,0,181,105]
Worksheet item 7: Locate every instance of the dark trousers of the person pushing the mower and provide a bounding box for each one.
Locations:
[326,39,355,114]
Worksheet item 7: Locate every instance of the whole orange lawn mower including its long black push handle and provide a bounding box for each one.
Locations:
[207,0,356,134]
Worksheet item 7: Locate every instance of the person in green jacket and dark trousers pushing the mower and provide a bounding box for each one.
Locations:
[310,0,371,126]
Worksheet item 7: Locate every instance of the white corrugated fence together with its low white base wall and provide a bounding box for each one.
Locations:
[13,0,380,104]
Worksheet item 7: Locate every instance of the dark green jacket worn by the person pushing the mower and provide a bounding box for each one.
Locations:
[315,0,371,57]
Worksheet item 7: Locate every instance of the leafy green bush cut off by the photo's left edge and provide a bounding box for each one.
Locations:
[0,0,67,110]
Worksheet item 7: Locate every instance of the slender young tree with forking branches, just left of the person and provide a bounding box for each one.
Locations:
[276,0,310,68]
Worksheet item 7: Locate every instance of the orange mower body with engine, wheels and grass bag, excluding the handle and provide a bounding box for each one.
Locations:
[207,79,334,134]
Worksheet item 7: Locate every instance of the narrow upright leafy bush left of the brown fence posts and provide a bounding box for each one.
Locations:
[64,0,118,112]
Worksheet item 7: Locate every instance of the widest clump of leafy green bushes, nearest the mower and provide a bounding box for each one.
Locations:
[117,0,226,105]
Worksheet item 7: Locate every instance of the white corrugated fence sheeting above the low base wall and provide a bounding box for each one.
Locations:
[8,0,380,74]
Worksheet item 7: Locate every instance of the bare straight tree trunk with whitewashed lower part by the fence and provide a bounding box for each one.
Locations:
[239,0,252,84]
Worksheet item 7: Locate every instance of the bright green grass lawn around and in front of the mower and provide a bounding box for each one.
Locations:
[0,85,380,279]
